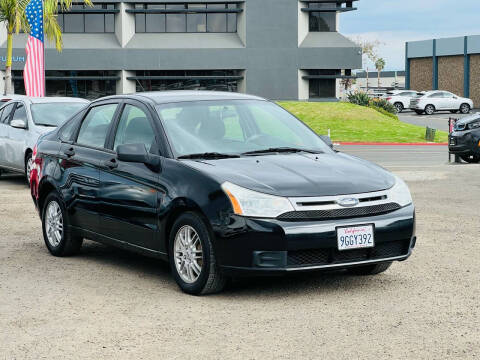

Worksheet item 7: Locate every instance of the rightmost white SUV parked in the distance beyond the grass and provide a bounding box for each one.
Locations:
[410,90,473,115]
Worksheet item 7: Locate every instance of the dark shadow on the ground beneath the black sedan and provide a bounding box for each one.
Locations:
[77,241,395,299]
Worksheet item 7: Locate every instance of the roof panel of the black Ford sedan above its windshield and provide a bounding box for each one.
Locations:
[94,90,265,104]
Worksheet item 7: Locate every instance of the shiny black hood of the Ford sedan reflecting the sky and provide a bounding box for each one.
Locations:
[182,153,395,197]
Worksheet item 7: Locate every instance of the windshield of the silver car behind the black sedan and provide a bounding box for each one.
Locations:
[30,102,85,127]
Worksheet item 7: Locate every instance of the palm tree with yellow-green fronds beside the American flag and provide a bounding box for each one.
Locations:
[0,0,92,94]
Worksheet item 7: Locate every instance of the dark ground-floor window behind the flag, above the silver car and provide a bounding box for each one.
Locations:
[13,70,120,100]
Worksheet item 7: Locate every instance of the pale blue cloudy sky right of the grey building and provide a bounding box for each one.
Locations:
[340,0,480,71]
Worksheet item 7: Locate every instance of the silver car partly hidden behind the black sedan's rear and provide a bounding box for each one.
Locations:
[0,97,89,180]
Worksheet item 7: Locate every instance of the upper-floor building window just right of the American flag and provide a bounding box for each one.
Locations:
[57,4,118,33]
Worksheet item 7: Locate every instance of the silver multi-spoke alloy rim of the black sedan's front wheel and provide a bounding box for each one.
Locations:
[174,225,204,284]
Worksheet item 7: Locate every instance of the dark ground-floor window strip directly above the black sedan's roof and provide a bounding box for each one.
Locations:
[128,70,243,92]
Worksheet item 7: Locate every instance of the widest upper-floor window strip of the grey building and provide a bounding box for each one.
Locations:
[132,3,242,33]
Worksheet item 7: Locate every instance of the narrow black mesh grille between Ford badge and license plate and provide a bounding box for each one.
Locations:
[277,203,401,221]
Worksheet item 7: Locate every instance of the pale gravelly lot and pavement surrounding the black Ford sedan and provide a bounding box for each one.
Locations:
[0,146,480,359]
